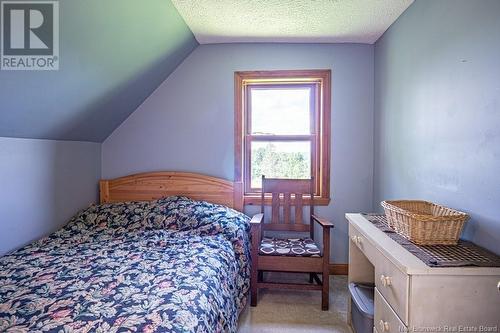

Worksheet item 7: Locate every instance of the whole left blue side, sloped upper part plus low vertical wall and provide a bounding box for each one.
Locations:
[0,0,198,255]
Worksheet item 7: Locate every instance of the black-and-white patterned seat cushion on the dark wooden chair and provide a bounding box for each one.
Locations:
[259,237,322,257]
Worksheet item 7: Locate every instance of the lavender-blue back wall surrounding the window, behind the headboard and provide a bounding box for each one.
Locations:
[102,44,373,263]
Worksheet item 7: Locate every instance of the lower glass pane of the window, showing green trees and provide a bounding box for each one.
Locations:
[250,141,311,188]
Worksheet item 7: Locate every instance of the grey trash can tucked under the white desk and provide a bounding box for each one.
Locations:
[349,283,375,333]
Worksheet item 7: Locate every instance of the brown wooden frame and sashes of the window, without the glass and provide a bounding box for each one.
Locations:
[234,69,331,205]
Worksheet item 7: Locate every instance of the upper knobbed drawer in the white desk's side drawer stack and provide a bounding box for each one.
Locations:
[375,250,409,322]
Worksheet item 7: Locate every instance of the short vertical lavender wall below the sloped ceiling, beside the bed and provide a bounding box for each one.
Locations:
[0,137,100,256]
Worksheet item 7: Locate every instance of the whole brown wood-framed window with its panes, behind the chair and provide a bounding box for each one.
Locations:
[235,70,331,204]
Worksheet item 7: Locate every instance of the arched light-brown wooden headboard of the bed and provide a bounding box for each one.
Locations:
[99,171,243,211]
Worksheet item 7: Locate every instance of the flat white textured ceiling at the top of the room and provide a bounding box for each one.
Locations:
[172,0,413,44]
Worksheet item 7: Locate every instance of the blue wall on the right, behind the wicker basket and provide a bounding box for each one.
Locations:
[374,0,500,253]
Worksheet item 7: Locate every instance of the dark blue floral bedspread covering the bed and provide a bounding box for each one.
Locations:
[0,197,250,333]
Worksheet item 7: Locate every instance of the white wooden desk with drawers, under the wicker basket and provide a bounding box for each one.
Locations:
[346,214,500,333]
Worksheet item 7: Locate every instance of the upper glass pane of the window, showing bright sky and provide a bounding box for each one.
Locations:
[250,87,311,135]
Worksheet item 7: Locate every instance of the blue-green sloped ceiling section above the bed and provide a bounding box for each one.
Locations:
[0,0,198,142]
